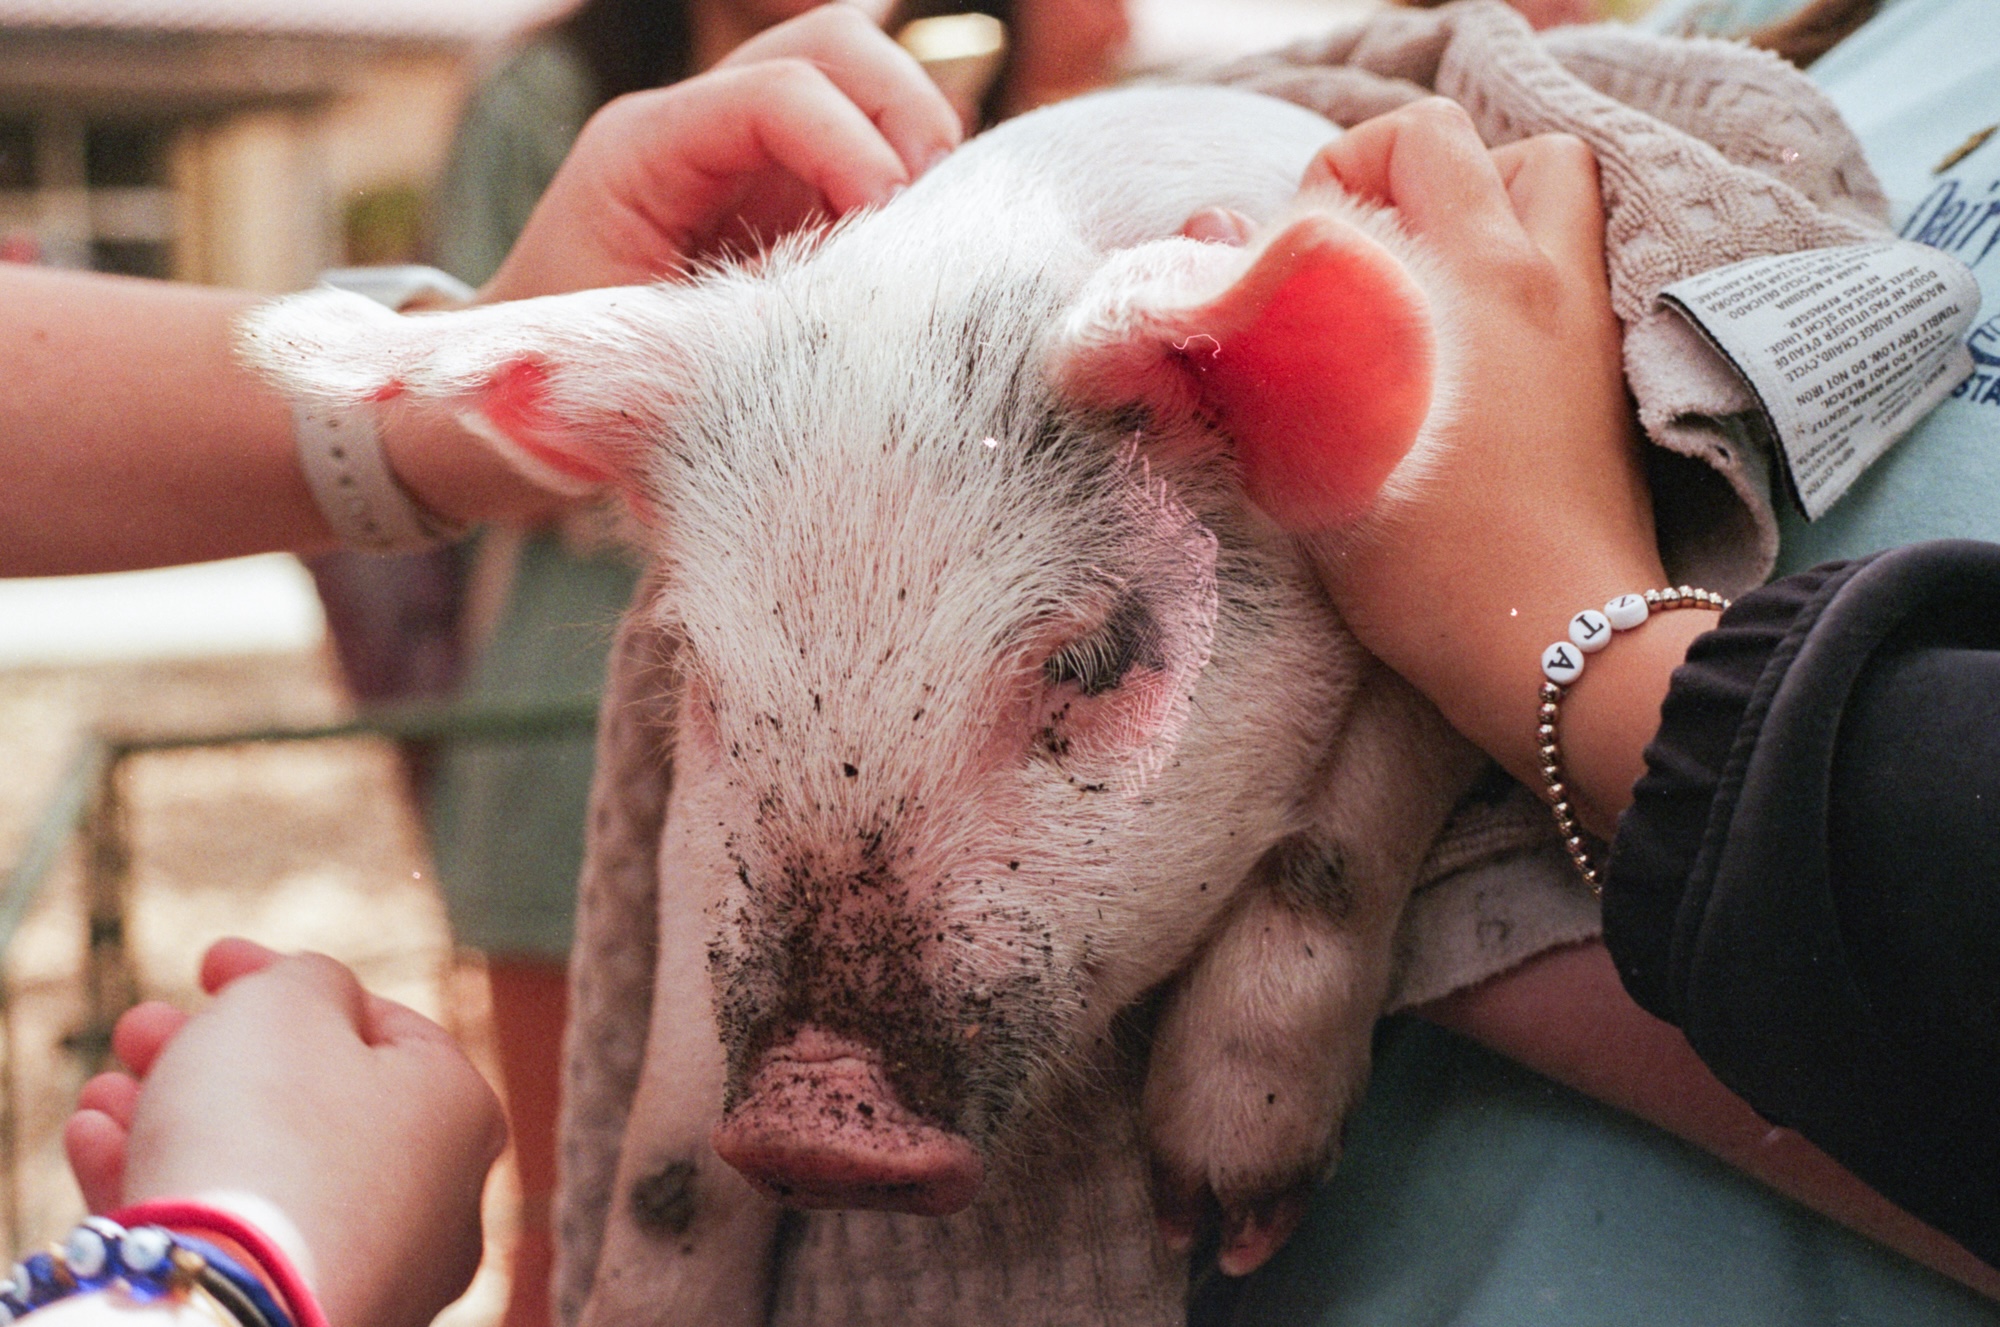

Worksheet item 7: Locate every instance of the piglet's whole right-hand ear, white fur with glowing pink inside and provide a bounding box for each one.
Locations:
[1050,208,1440,532]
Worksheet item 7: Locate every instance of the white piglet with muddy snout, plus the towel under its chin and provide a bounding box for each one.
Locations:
[242,88,1480,1327]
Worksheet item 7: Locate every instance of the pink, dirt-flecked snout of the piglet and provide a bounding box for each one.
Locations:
[710,1027,986,1217]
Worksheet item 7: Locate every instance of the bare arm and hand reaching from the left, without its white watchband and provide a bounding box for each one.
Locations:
[0,6,958,576]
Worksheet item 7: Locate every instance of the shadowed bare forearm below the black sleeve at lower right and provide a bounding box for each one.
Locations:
[1420,943,2000,1299]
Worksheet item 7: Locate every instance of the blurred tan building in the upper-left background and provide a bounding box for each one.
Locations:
[0,0,550,290]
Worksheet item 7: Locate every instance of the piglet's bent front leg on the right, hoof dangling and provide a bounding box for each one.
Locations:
[1144,664,1480,1275]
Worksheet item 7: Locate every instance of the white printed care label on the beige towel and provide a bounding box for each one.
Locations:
[1660,240,1980,520]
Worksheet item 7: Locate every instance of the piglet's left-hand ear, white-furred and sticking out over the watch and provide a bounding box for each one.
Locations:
[238,286,694,502]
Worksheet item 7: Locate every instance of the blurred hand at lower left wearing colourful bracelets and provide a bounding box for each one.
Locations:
[64,941,506,1327]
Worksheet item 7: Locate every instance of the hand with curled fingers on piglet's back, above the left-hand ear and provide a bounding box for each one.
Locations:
[480,4,960,300]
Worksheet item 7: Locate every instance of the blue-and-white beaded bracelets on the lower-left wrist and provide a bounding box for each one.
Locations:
[0,1217,296,1327]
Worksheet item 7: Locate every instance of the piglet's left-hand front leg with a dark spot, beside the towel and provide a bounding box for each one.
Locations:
[582,787,778,1327]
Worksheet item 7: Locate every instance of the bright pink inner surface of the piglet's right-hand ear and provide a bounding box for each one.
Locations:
[1176,216,1436,530]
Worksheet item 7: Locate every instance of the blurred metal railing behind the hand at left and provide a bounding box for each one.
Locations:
[0,695,598,1247]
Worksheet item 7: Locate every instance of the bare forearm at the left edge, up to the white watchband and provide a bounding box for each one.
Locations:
[0,268,332,576]
